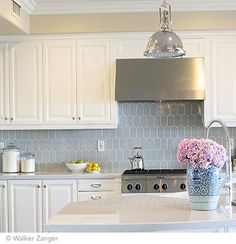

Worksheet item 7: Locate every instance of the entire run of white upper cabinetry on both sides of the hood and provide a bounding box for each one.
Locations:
[0,32,236,130]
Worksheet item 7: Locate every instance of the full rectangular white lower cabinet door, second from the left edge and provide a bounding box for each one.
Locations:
[8,180,42,232]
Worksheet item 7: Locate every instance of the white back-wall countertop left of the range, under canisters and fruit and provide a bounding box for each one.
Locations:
[0,171,121,180]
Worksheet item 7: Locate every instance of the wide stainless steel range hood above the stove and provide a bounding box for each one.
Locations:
[115,58,205,102]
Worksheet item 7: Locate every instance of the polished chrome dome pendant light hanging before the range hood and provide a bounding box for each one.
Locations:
[144,0,185,58]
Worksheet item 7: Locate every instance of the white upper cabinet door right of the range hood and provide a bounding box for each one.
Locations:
[210,36,236,127]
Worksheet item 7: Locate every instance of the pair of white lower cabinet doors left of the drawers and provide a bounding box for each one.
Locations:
[6,180,77,232]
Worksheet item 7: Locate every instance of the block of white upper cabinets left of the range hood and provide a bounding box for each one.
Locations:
[0,38,118,129]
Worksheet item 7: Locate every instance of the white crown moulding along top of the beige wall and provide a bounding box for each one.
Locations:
[14,0,236,15]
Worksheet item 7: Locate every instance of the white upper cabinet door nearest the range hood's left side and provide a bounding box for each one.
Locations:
[77,40,112,124]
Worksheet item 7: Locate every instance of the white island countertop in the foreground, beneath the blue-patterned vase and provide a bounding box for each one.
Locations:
[44,192,236,232]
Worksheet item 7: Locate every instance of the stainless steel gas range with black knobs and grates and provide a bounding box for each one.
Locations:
[121,169,186,193]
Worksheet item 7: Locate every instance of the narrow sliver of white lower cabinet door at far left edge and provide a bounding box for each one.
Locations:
[0,181,8,232]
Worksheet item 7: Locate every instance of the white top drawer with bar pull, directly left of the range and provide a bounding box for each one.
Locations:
[78,179,119,192]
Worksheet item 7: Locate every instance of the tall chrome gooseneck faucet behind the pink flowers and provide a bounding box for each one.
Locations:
[207,119,235,205]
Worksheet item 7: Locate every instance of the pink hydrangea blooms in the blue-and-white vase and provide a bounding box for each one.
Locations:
[177,139,227,169]
